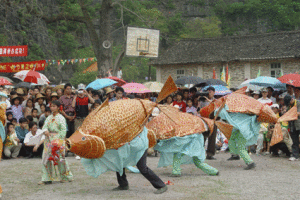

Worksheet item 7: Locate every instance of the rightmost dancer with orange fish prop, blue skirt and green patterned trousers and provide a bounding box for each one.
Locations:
[200,92,298,170]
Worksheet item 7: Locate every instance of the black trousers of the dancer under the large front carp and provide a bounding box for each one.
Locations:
[117,150,165,189]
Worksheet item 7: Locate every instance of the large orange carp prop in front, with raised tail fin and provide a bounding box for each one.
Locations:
[66,77,177,159]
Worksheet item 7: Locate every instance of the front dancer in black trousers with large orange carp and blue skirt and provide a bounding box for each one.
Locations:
[66,77,177,194]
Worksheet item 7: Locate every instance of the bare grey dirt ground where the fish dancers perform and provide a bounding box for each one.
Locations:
[0,153,300,200]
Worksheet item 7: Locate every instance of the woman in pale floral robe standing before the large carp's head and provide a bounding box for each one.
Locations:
[38,101,73,185]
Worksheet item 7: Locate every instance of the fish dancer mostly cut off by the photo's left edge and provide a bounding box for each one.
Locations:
[0,92,8,198]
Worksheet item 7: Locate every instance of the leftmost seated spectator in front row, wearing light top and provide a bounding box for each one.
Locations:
[4,123,22,158]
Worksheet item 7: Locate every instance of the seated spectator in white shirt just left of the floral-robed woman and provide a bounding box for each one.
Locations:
[24,122,45,158]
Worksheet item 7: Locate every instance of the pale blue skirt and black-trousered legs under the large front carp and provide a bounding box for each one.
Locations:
[81,127,167,194]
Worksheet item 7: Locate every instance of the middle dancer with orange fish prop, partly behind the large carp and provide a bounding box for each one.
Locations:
[146,106,232,177]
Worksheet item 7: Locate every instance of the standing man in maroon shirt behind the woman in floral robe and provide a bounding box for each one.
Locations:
[59,83,75,138]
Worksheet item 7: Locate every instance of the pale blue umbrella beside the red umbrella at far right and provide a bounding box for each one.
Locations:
[250,76,286,90]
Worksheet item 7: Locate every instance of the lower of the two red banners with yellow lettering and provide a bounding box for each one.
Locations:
[0,60,46,73]
